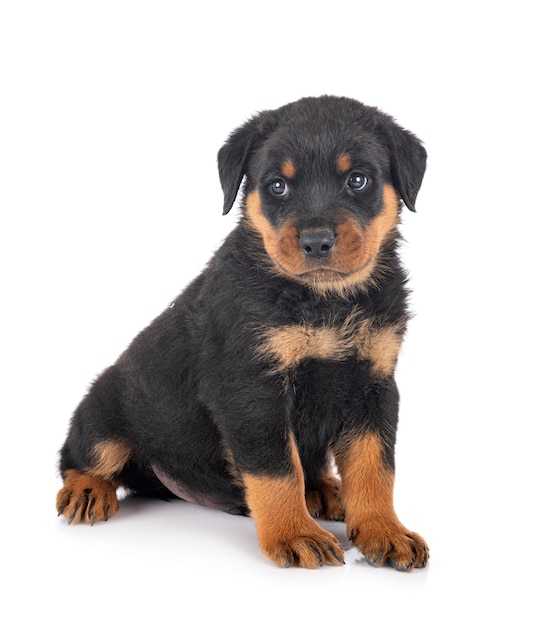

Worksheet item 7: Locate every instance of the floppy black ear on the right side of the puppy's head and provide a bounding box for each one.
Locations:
[377,113,427,211]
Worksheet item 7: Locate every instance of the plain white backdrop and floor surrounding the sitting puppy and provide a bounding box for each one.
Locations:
[0,0,552,625]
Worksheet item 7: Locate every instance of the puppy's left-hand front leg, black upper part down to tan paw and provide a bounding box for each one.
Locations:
[209,358,344,568]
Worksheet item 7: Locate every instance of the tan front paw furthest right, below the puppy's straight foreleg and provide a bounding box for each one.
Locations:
[348,521,429,572]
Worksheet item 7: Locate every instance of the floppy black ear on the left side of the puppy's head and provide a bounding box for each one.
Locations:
[218,111,273,215]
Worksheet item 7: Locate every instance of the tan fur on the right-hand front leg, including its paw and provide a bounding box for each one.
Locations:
[335,434,429,571]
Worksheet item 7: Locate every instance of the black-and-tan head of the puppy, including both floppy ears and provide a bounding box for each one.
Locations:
[218,96,426,293]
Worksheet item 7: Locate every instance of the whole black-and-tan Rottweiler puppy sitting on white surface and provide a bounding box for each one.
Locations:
[57,96,429,570]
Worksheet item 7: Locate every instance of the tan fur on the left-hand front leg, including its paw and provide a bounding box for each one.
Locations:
[244,438,343,568]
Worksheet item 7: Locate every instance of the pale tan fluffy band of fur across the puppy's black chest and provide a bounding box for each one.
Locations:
[259,314,406,376]
